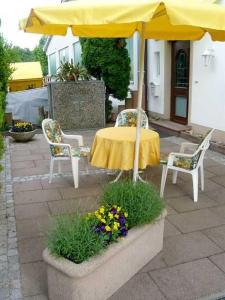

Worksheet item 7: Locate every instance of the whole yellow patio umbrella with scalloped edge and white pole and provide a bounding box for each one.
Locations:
[20,0,225,181]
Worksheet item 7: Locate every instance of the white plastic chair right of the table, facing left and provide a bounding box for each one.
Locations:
[160,129,214,202]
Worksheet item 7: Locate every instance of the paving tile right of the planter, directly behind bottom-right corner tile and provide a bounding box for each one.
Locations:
[163,232,222,266]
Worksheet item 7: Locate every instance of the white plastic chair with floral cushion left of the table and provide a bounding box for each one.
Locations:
[42,119,90,188]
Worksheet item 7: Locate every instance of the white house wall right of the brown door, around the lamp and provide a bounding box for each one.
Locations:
[189,35,225,131]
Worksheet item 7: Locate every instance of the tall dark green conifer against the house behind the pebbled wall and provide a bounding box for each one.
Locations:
[80,38,130,121]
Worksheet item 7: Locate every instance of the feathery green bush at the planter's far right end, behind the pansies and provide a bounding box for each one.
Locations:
[101,181,164,228]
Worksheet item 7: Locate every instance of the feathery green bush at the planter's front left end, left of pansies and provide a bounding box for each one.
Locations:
[47,214,105,264]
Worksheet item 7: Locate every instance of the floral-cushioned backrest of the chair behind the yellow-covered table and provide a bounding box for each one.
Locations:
[115,109,148,129]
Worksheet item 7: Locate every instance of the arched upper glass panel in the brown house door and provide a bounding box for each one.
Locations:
[175,49,189,88]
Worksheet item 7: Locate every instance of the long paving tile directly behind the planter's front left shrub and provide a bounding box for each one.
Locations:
[48,196,98,215]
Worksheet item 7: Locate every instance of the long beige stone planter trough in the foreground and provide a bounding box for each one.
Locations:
[43,211,166,300]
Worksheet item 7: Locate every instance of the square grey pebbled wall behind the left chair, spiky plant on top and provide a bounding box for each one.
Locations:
[48,80,105,129]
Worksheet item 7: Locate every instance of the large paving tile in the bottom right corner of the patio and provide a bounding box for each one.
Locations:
[150,258,225,300]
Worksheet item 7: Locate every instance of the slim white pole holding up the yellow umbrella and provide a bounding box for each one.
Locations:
[133,34,145,182]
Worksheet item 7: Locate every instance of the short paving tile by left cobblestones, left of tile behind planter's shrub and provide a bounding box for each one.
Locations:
[15,203,50,221]
